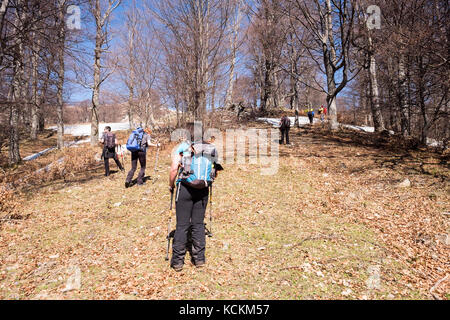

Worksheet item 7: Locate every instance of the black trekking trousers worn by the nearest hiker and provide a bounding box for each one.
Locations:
[170,183,209,266]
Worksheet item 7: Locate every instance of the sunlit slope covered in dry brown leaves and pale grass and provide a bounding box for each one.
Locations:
[0,124,450,299]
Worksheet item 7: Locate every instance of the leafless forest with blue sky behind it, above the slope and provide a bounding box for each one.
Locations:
[0,0,450,165]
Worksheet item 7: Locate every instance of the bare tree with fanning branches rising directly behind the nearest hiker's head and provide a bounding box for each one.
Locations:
[148,0,229,119]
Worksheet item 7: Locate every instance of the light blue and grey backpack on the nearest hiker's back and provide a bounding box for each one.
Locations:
[178,142,217,189]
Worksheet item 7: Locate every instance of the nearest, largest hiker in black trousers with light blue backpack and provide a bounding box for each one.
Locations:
[169,123,218,271]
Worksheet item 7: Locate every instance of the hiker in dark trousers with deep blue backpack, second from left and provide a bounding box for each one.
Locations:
[125,127,159,188]
